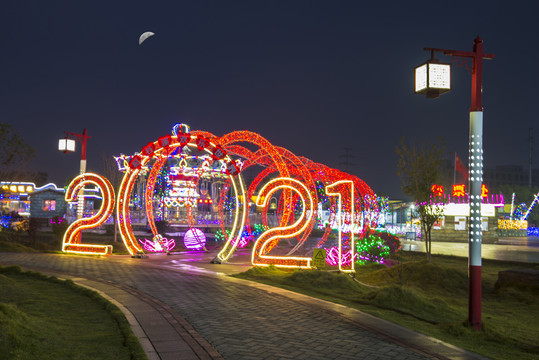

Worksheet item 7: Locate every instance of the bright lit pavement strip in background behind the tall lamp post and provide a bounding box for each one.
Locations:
[402,237,539,263]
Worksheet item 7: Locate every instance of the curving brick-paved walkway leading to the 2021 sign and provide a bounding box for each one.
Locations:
[0,253,488,360]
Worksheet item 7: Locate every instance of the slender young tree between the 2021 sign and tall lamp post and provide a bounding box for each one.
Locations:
[395,138,445,262]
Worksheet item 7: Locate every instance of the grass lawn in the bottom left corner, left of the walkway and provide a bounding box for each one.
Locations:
[0,266,147,360]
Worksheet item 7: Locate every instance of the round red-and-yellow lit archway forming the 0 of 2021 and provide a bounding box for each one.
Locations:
[117,126,246,260]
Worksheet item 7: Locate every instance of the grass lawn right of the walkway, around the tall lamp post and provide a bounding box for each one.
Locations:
[234,253,539,360]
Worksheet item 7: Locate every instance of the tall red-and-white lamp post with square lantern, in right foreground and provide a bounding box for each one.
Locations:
[416,36,495,330]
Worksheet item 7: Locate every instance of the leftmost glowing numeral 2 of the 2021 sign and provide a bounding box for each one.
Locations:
[62,173,114,255]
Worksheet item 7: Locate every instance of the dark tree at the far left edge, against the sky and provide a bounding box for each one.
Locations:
[0,123,36,181]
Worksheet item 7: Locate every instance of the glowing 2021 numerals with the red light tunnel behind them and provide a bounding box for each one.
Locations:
[62,126,377,271]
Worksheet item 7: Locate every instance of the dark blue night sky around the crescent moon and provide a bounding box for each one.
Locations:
[0,0,539,198]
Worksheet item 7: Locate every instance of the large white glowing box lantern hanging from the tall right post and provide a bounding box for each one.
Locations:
[415,58,451,98]
